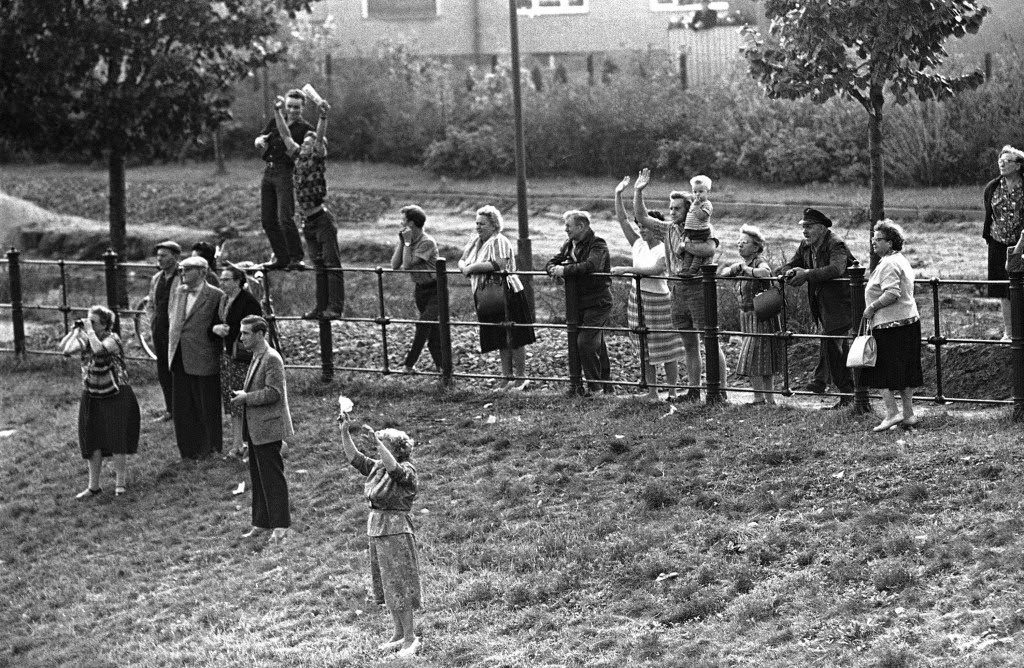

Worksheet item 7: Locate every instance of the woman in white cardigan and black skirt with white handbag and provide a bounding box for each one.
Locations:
[860,219,925,431]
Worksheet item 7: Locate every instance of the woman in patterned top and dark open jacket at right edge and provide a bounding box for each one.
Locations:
[981,144,1024,341]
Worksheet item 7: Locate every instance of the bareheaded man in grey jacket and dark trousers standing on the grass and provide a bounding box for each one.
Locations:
[231,316,295,542]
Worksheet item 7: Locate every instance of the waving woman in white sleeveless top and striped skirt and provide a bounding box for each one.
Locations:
[611,176,685,402]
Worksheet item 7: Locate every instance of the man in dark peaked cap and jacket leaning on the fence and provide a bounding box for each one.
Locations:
[779,208,857,410]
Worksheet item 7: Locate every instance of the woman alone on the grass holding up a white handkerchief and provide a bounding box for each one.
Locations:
[338,418,421,657]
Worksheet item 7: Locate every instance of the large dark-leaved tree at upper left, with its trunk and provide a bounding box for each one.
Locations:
[0,0,315,298]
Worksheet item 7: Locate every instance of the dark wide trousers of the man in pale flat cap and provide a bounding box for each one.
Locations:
[171,350,223,459]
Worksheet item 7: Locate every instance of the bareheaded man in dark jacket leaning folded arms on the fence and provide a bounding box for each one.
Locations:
[544,209,614,394]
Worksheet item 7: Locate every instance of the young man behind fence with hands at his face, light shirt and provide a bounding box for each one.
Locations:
[391,204,441,373]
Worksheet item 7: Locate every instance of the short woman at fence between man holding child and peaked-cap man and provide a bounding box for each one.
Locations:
[719,225,785,406]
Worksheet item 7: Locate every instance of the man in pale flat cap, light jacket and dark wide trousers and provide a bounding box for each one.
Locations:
[167,257,224,460]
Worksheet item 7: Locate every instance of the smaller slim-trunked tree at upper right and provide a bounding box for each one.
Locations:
[741,0,988,266]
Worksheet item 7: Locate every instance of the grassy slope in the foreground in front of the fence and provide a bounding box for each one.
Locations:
[0,358,1024,668]
